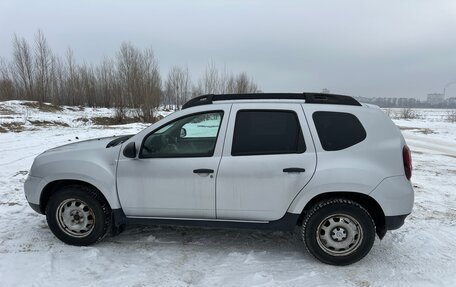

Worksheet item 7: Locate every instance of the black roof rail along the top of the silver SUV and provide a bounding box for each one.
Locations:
[182,93,361,109]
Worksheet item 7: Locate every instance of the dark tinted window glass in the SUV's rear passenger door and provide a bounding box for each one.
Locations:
[231,110,306,156]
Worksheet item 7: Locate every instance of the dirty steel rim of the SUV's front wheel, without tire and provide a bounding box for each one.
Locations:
[56,198,95,237]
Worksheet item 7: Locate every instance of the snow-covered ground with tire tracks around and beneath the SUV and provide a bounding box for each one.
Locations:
[0,101,456,286]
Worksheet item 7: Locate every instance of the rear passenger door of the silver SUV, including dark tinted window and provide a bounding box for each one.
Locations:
[216,103,316,221]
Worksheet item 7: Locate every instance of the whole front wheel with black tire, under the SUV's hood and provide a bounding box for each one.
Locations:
[46,185,111,246]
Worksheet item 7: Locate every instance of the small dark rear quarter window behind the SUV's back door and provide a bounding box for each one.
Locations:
[312,112,366,151]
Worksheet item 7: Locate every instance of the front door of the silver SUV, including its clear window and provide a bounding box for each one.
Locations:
[117,105,229,219]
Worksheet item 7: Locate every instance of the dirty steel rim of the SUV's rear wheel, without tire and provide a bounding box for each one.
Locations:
[316,214,363,256]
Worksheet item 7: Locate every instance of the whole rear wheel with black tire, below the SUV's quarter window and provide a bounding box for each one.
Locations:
[302,198,375,265]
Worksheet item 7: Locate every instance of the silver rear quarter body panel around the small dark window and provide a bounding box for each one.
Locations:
[288,105,414,216]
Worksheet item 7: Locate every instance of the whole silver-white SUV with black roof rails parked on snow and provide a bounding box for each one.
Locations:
[25,93,414,265]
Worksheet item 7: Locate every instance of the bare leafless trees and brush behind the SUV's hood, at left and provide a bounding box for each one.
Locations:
[0,31,260,122]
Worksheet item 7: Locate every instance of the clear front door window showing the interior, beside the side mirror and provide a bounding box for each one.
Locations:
[140,111,223,158]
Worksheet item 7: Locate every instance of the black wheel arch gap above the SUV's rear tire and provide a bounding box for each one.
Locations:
[298,191,386,239]
